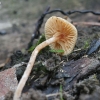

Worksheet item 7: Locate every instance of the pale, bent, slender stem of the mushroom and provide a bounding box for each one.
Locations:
[13,37,58,100]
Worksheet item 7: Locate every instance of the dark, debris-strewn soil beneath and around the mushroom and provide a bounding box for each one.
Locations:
[2,19,100,100]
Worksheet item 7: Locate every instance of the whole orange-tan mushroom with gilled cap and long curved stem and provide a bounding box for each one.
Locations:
[14,16,77,100]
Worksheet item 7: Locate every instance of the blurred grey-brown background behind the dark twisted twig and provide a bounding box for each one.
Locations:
[0,0,100,63]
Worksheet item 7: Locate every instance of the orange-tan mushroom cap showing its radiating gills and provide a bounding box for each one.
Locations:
[45,16,77,55]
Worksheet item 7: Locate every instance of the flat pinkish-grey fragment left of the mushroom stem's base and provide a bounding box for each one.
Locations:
[0,68,18,100]
